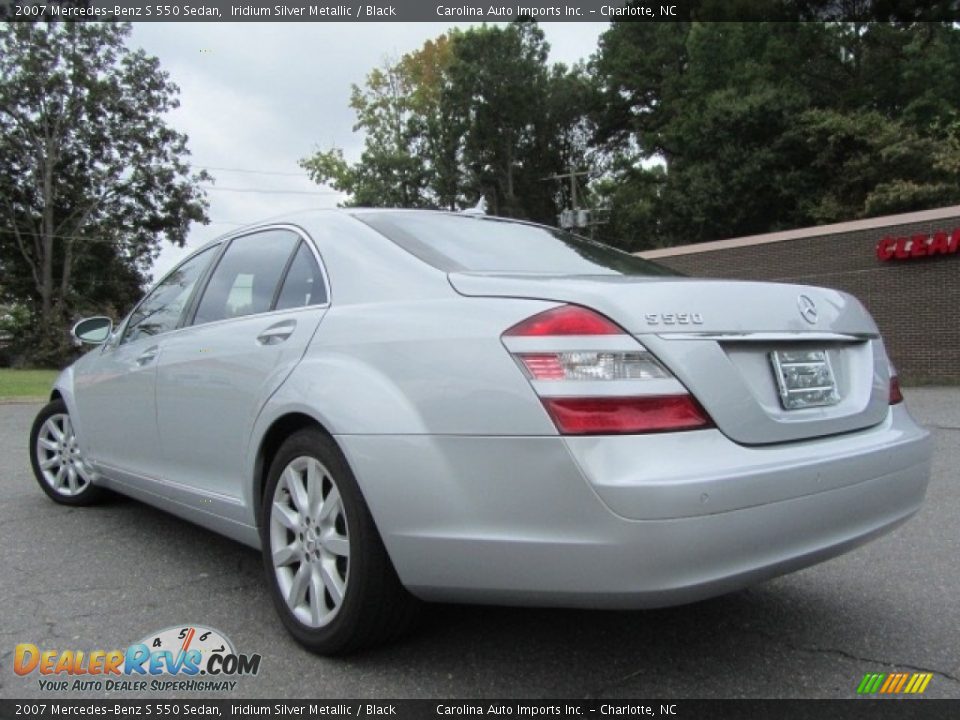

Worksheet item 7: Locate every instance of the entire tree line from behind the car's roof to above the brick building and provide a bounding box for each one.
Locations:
[290,20,960,250]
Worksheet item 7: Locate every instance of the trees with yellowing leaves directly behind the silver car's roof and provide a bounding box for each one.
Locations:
[301,23,593,222]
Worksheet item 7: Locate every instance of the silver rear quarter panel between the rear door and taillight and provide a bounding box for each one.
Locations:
[238,215,557,522]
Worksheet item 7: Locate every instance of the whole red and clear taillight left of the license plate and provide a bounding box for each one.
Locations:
[503,305,713,435]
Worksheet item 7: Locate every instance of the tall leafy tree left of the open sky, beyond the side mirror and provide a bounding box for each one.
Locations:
[0,23,209,362]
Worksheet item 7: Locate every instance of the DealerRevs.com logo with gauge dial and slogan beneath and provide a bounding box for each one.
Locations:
[13,625,261,692]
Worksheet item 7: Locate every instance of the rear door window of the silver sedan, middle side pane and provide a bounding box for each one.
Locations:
[194,230,300,325]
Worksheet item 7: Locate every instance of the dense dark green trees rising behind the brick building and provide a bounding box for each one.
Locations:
[592,22,960,248]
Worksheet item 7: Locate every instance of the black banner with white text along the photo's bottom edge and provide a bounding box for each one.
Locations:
[0,699,960,720]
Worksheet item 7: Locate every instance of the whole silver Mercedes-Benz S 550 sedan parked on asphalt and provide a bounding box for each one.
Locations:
[30,210,930,653]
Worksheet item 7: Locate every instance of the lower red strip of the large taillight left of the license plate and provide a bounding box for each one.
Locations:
[541,395,713,435]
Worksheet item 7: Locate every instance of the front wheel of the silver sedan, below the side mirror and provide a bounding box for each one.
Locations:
[30,400,105,506]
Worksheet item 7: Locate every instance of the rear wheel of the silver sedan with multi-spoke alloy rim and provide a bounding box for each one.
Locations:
[260,428,419,655]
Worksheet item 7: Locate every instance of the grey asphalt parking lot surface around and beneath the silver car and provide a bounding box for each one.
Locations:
[0,388,960,699]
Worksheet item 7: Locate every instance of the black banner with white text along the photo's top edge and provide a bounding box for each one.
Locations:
[0,0,960,22]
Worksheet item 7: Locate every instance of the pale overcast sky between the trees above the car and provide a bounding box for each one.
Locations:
[130,22,608,280]
